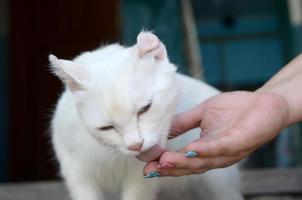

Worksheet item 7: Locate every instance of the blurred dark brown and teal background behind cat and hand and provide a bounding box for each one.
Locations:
[0,0,302,182]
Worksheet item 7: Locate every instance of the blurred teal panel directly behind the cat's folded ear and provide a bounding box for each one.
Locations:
[121,0,187,73]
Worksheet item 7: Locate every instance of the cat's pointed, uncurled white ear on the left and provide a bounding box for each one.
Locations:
[48,54,89,92]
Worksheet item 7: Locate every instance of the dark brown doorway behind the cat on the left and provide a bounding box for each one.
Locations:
[9,0,119,181]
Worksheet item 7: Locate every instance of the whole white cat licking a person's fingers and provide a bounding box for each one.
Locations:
[49,32,242,200]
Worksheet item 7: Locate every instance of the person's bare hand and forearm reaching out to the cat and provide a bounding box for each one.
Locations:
[139,55,302,176]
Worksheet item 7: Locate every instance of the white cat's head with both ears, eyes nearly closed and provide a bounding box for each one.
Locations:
[49,32,178,156]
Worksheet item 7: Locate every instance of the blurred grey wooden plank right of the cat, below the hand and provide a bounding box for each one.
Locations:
[242,168,302,196]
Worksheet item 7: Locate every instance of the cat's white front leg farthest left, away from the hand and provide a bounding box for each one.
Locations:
[61,157,105,200]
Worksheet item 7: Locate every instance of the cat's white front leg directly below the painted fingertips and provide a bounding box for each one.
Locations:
[122,162,159,200]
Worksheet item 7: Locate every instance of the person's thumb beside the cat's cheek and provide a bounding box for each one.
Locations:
[169,103,204,139]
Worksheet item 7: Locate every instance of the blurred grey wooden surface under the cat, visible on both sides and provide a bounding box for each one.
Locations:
[0,169,302,200]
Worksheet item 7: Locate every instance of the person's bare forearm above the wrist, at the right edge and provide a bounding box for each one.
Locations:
[257,54,302,125]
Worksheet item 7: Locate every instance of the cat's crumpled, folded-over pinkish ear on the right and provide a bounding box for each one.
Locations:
[136,32,167,60]
